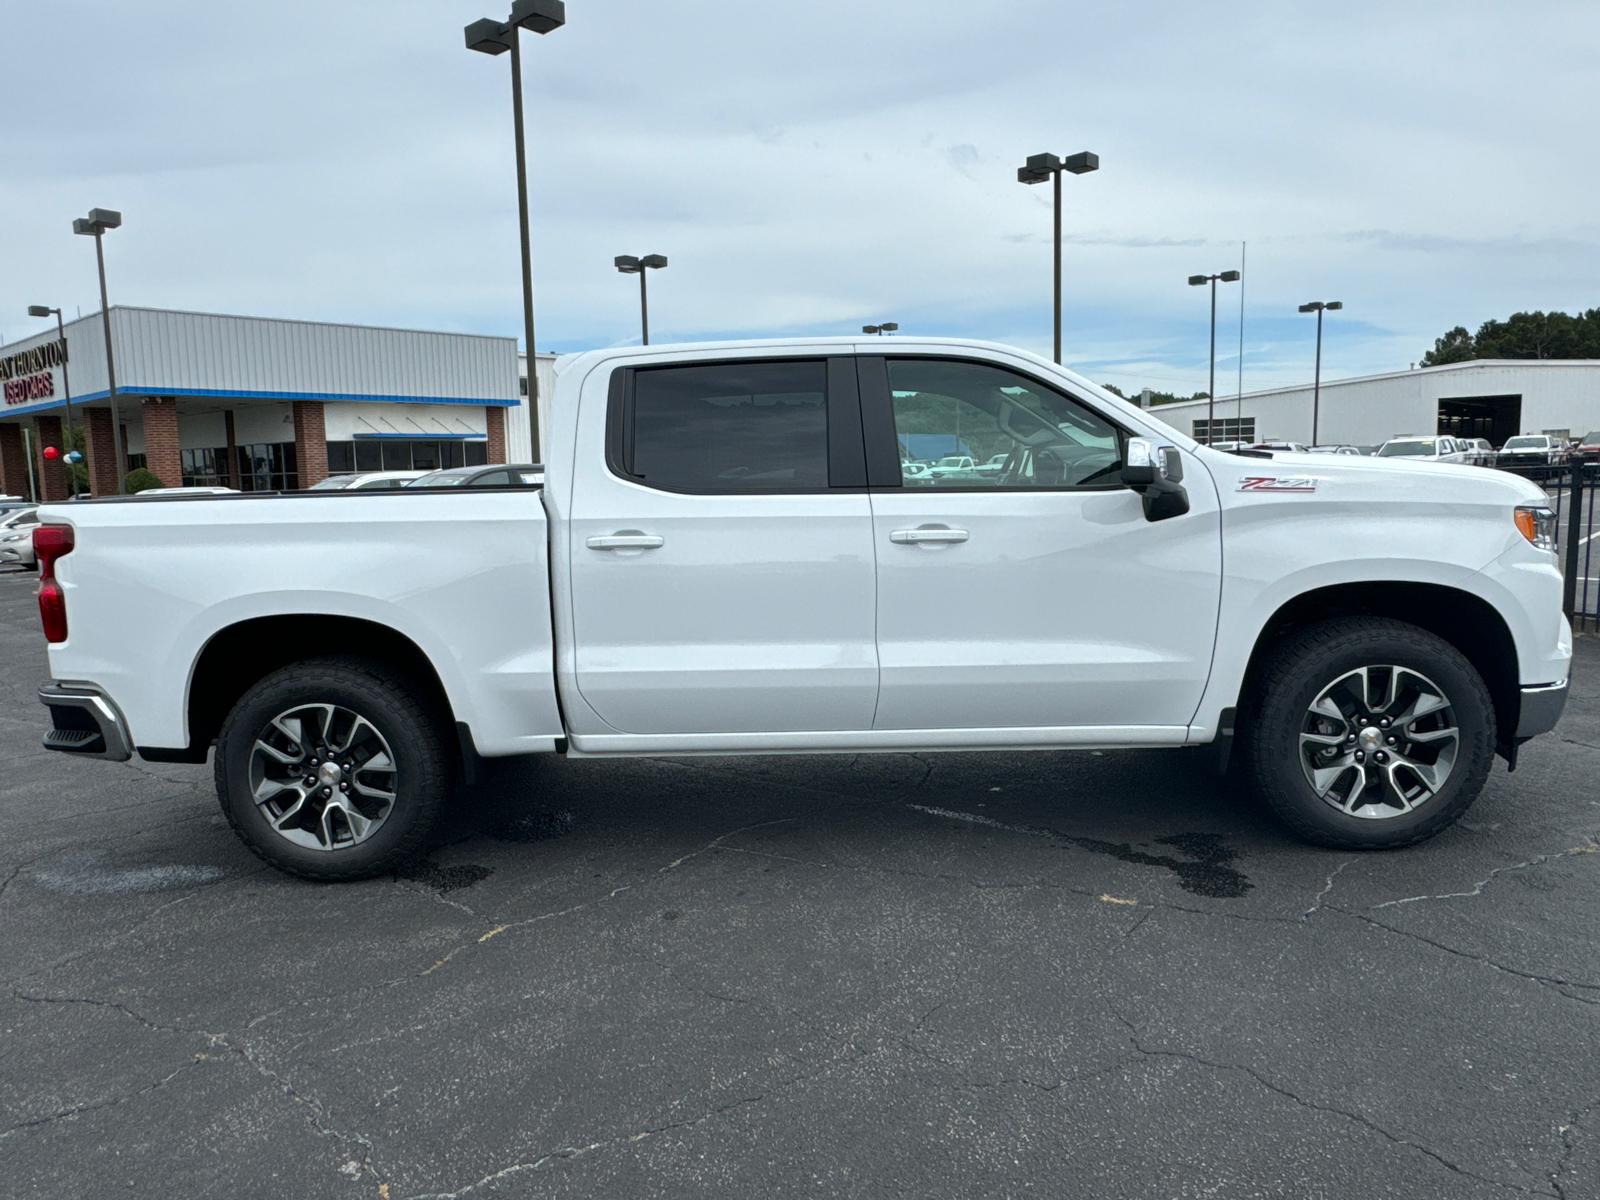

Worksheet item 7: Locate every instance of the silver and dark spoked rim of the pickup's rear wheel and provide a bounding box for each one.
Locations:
[250,704,398,850]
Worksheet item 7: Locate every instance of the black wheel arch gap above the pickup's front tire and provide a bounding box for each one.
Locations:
[1238,581,1522,754]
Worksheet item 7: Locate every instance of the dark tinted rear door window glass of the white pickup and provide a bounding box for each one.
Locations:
[621,360,827,493]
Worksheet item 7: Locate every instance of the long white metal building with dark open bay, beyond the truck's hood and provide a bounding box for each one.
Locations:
[1152,358,1600,446]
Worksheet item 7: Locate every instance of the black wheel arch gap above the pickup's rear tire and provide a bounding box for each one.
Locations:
[156,613,454,763]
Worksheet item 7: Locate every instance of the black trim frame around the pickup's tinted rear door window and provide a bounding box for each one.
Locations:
[605,354,869,496]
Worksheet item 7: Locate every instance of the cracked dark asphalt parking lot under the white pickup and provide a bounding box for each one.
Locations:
[0,574,1600,1200]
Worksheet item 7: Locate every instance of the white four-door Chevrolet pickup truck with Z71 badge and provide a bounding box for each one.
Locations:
[37,339,1571,878]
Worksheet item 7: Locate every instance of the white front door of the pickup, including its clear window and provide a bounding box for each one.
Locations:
[859,357,1222,741]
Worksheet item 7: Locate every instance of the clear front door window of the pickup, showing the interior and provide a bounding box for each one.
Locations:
[888,358,1122,488]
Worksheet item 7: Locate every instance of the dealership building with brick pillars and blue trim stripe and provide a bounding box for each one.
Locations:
[0,306,555,499]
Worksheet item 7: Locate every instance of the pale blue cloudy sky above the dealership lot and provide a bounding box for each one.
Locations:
[0,0,1600,395]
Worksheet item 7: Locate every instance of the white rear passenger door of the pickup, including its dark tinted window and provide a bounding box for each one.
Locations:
[568,357,878,734]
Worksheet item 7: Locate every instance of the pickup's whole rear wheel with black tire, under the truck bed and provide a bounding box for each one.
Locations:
[214,656,451,882]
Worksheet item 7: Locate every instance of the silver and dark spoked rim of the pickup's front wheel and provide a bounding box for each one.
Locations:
[1299,666,1461,821]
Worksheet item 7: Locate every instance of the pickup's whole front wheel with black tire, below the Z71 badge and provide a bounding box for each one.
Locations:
[1243,618,1496,850]
